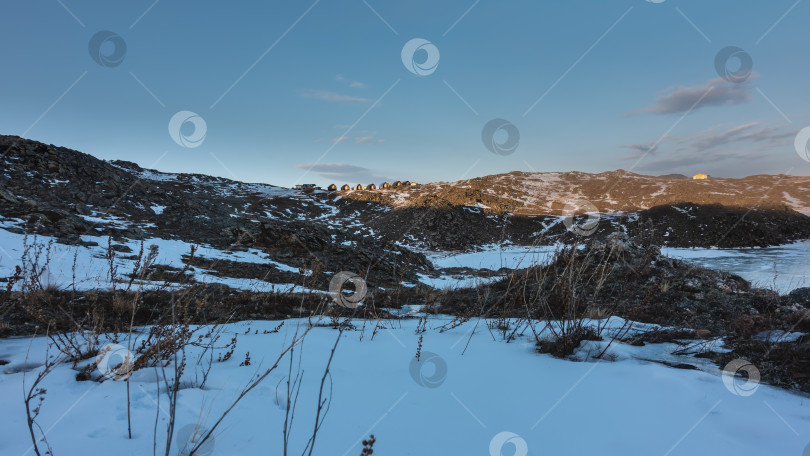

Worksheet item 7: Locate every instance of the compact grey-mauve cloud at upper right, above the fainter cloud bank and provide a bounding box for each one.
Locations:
[628,78,752,115]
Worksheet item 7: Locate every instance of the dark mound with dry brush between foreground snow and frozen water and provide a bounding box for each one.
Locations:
[439,235,810,336]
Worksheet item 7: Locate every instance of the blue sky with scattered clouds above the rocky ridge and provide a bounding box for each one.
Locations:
[0,0,810,186]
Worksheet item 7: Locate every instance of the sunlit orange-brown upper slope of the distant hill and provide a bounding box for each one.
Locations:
[346,170,810,216]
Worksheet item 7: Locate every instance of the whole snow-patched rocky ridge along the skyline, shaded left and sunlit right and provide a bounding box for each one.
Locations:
[0,136,810,260]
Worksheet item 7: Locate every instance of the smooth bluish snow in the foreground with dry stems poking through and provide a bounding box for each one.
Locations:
[0,317,810,456]
